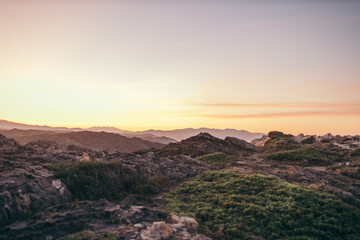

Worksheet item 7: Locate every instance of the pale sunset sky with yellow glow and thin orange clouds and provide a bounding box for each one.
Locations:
[0,0,360,134]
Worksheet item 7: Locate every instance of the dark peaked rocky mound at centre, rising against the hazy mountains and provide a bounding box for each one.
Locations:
[156,133,257,157]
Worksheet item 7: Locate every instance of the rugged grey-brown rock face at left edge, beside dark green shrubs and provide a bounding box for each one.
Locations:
[0,136,71,226]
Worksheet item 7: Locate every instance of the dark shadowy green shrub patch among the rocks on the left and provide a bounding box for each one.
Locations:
[50,162,160,200]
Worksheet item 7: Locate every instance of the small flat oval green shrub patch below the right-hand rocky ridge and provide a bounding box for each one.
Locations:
[266,147,332,166]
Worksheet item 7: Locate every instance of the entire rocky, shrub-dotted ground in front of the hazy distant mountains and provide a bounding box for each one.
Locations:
[0,131,360,240]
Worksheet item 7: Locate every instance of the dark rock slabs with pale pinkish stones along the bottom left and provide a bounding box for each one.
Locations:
[0,195,210,240]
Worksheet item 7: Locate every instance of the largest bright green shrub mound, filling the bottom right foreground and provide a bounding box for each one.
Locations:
[163,170,360,239]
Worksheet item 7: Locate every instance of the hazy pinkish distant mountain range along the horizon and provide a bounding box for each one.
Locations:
[0,120,264,144]
